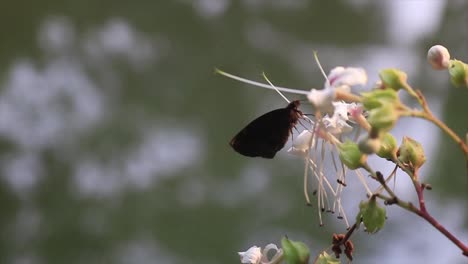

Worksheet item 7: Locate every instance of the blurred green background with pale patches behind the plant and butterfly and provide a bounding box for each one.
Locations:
[0,0,468,264]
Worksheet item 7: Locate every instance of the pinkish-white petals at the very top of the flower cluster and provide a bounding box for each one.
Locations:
[325,67,367,91]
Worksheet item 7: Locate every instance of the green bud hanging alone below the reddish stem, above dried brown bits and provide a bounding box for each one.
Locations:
[356,197,387,233]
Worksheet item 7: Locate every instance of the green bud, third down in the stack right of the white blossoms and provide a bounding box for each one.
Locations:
[367,104,400,131]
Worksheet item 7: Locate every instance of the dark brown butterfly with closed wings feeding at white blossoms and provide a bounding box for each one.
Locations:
[229,101,302,159]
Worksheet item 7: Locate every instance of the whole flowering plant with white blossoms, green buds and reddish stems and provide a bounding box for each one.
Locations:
[217,45,468,264]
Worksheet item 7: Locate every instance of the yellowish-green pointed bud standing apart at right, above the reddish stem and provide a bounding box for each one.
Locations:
[398,137,426,173]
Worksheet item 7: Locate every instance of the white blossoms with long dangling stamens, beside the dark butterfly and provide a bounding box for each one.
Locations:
[288,67,368,227]
